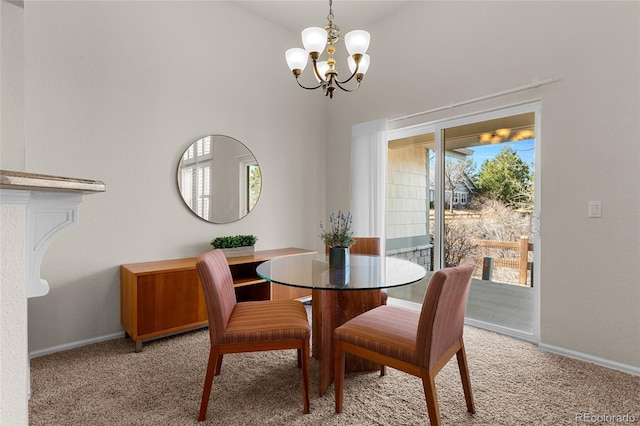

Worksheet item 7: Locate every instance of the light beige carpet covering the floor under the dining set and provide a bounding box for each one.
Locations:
[29,327,640,426]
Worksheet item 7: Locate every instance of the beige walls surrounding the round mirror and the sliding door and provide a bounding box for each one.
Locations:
[3,2,640,374]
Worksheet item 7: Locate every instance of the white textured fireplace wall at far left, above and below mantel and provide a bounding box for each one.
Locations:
[0,1,28,425]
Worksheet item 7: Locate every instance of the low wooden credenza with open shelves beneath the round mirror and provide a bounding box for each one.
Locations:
[120,247,313,352]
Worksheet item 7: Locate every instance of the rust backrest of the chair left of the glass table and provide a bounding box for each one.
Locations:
[196,249,237,344]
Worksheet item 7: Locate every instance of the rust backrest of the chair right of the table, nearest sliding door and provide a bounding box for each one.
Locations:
[416,258,476,369]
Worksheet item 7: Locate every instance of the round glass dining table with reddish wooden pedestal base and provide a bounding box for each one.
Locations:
[256,253,426,396]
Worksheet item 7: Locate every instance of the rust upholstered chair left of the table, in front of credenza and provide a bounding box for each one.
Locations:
[196,250,311,421]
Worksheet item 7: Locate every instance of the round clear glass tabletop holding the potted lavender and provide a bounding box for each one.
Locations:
[256,253,426,290]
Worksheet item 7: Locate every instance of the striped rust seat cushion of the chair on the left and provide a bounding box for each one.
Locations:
[224,300,311,343]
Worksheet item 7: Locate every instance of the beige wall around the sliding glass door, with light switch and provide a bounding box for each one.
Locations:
[327,1,640,369]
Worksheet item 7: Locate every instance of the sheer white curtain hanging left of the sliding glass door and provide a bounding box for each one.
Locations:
[351,119,388,253]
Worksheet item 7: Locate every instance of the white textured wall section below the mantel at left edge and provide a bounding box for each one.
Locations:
[0,203,28,425]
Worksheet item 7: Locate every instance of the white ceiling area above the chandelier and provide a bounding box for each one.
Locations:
[231,0,408,35]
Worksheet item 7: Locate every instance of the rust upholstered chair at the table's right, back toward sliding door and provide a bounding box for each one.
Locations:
[334,259,475,426]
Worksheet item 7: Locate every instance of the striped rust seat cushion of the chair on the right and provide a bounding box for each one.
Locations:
[333,306,420,364]
